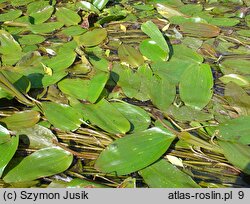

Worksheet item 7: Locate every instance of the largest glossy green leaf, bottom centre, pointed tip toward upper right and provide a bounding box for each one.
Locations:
[95,127,175,175]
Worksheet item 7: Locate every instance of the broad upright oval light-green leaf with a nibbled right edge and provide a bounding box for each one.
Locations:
[180,64,213,109]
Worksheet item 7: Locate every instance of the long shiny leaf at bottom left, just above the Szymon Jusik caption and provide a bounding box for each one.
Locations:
[3,147,73,183]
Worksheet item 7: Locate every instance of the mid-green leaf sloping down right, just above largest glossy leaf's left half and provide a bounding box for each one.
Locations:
[83,99,130,134]
